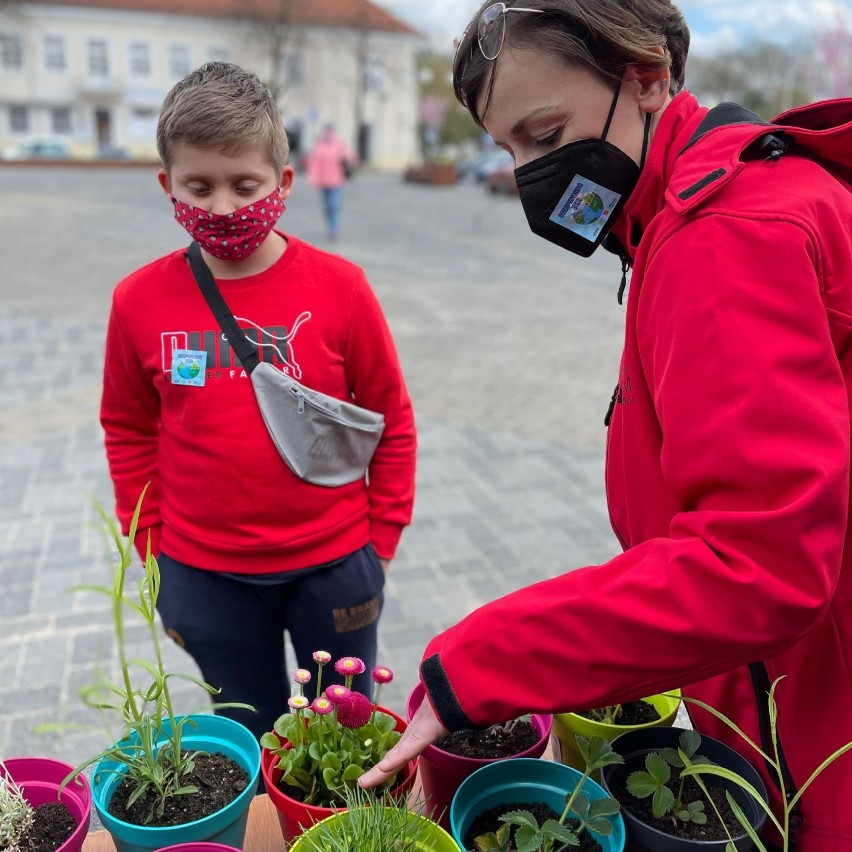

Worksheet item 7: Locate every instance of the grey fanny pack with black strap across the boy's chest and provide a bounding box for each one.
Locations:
[189,242,385,487]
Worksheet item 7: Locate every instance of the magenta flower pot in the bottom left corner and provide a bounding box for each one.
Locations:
[0,757,92,852]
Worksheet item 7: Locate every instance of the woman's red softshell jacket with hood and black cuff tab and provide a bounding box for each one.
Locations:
[421,93,852,852]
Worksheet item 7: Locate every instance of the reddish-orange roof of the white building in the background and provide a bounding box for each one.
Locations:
[29,0,419,35]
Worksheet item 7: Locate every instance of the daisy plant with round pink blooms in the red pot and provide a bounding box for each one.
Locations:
[260,651,401,808]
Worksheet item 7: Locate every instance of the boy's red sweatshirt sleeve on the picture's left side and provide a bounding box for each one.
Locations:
[101,297,162,559]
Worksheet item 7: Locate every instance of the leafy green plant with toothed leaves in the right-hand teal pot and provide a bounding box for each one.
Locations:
[474,736,624,852]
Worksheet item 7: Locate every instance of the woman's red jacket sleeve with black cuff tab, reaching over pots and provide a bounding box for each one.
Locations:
[421,215,850,729]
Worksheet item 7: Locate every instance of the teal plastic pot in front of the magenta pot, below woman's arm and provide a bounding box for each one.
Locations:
[450,757,624,852]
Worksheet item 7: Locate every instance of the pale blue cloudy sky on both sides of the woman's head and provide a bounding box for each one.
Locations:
[374,0,852,53]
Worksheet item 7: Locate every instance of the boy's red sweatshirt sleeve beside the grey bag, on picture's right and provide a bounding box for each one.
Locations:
[345,270,417,559]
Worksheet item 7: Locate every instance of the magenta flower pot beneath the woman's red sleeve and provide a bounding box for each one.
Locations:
[406,683,553,831]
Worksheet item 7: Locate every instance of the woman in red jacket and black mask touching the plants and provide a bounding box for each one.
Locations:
[361,0,852,852]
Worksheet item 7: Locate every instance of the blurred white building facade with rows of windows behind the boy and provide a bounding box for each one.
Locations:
[0,0,421,168]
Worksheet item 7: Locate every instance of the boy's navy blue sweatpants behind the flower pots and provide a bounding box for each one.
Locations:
[157,544,385,739]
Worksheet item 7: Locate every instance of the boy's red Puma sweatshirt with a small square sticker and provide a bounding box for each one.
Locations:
[101,237,416,574]
